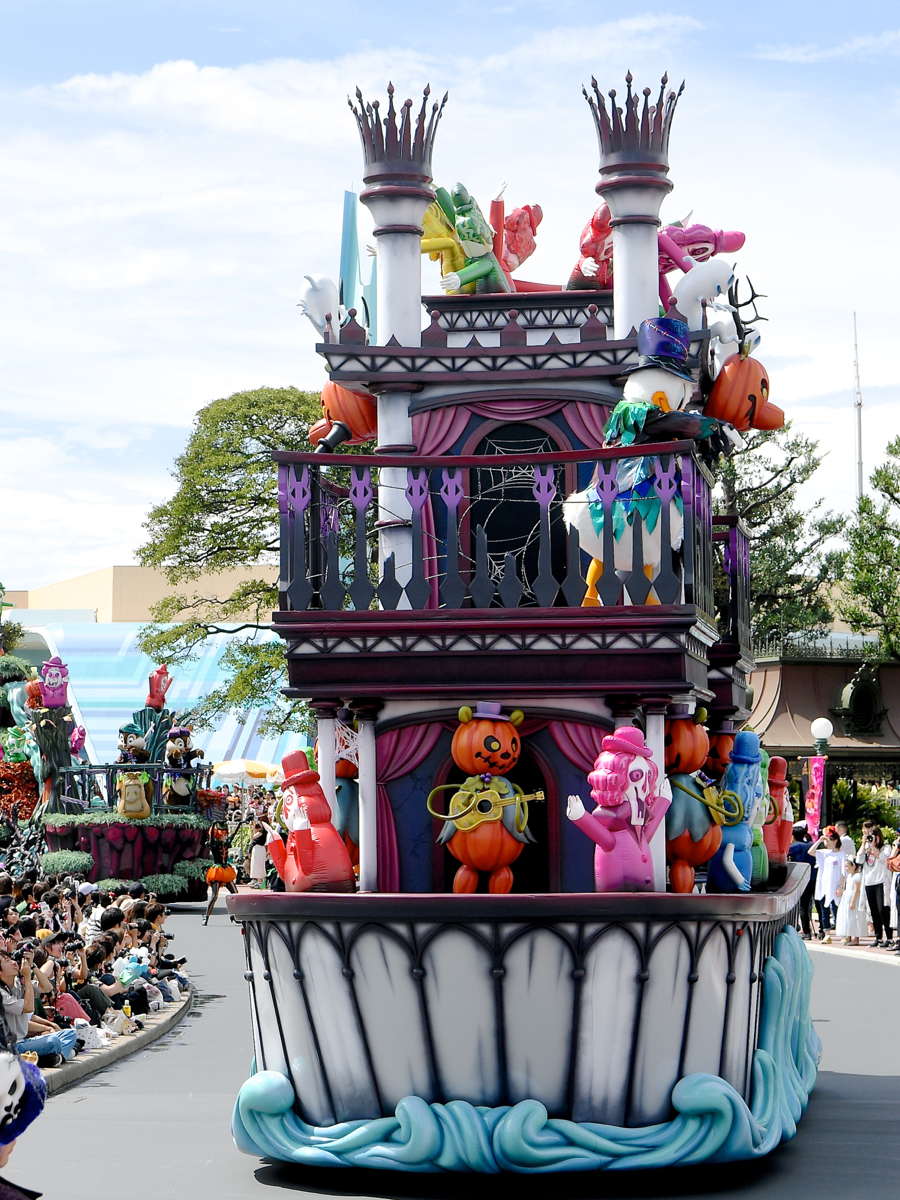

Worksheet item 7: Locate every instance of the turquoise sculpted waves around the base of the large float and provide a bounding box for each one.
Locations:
[232,926,822,1175]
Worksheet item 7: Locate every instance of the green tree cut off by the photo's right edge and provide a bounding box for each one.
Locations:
[839,438,900,661]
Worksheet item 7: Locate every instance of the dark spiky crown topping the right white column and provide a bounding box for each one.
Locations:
[581,71,684,170]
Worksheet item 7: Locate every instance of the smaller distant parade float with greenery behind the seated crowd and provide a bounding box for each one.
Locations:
[0,656,226,899]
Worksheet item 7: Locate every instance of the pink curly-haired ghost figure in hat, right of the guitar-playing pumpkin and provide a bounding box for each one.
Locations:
[566,727,671,892]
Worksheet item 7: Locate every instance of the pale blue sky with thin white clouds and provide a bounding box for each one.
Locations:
[0,0,900,587]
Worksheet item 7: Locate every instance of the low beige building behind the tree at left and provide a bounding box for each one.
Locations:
[5,565,278,624]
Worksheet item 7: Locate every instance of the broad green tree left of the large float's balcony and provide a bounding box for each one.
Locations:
[137,388,322,734]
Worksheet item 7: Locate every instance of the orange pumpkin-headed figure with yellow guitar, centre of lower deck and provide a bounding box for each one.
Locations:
[438,702,534,895]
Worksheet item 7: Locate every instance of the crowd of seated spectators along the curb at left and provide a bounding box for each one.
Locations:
[0,871,190,1067]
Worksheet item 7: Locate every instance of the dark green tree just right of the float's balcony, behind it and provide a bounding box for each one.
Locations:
[714,421,844,642]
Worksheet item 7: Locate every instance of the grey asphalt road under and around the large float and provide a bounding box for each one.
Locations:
[4,902,900,1200]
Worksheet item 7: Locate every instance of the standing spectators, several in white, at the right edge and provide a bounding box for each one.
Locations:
[788,821,900,956]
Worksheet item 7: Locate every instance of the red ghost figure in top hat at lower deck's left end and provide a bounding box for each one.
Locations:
[266,750,356,892]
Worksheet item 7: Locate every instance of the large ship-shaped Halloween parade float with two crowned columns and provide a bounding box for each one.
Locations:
[228,68,820,1174]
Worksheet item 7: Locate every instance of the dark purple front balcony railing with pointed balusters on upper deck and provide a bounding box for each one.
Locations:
[275,442,715,625]
